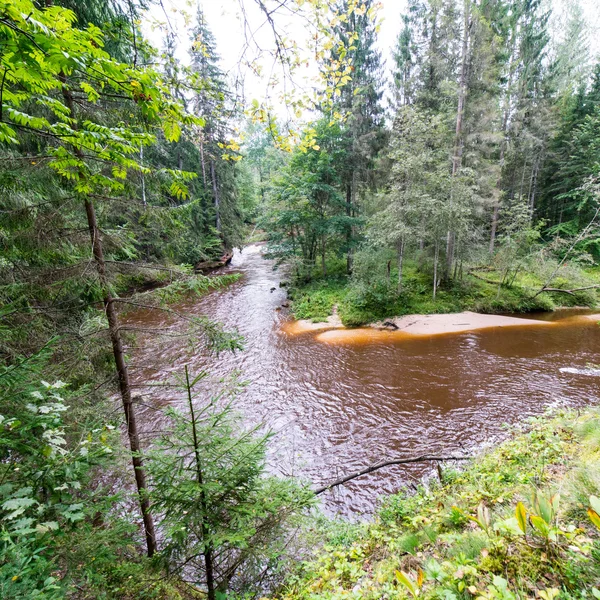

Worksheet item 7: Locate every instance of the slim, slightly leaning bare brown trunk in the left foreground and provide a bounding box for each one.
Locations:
[60,75,156,557]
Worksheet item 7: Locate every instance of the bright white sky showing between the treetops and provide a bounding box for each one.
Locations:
[143,0,600,109]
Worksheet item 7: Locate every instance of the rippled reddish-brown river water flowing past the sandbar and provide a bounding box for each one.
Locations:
[127,246,600,519]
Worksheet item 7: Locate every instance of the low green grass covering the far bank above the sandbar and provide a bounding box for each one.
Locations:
[290,255,597,327]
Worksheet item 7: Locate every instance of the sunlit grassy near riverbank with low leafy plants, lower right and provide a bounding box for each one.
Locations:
[274,408,600,600]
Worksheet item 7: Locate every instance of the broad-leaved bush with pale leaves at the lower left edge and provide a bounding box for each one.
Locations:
[0,352,114,599]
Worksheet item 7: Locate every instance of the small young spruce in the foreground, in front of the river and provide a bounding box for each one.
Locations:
[148,367,313,596]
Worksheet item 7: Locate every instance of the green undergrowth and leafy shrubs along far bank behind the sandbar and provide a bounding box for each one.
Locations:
[290,251,597,327]
